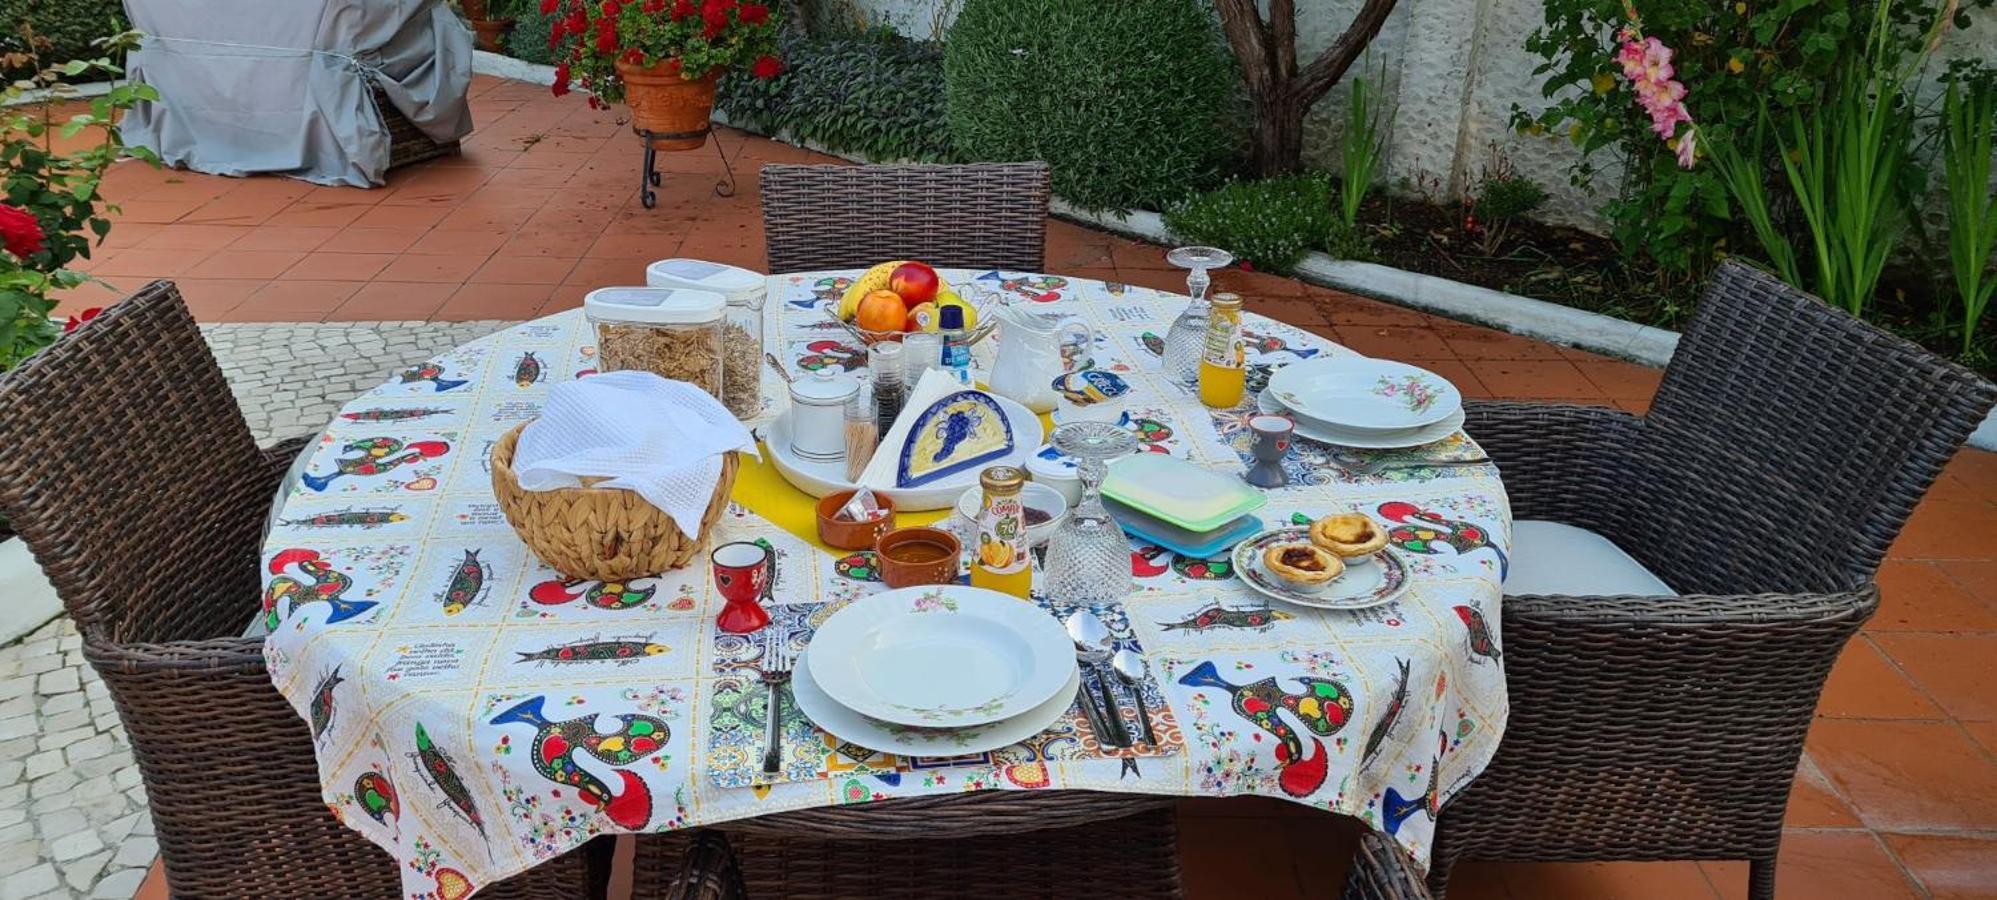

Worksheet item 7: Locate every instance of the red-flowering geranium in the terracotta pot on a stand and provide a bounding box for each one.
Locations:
[541,0,783,106]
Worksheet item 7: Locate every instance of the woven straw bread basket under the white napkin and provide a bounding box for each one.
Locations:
[491,423,739,581]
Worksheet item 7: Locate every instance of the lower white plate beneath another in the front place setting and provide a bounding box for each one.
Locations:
[791,645,1082,756]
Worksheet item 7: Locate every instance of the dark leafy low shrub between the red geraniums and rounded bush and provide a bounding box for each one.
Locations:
[715,28,955,162]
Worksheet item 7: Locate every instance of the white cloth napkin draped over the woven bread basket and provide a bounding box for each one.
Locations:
[513,369,757,535]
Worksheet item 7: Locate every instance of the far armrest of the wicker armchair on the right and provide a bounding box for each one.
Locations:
[1464,401,1644,533]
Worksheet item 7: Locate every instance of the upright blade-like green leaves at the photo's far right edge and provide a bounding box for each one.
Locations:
[1941,78,1997,355]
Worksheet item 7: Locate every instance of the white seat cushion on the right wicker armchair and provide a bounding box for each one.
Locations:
[1504,519,1677,597]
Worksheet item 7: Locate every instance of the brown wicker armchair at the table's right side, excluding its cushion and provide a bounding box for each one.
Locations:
[1430,263,1997,898]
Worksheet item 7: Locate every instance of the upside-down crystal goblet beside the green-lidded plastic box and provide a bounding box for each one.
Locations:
[1040,421,1136,605]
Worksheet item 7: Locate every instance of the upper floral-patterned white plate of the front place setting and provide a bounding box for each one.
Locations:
[811,585,1076,736]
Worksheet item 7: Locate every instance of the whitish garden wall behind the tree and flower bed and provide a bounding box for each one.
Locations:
[849,0,1997,236]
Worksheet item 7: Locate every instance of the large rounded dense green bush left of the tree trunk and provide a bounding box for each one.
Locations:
[943,0,1238,210]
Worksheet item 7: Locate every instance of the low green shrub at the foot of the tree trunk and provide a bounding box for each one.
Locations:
[1164,176,1352,271]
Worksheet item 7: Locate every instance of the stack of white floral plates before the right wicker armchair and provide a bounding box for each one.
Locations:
[1258,357,1464,449]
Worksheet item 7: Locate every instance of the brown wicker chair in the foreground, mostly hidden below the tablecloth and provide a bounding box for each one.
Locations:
[631,790,1184,900]
